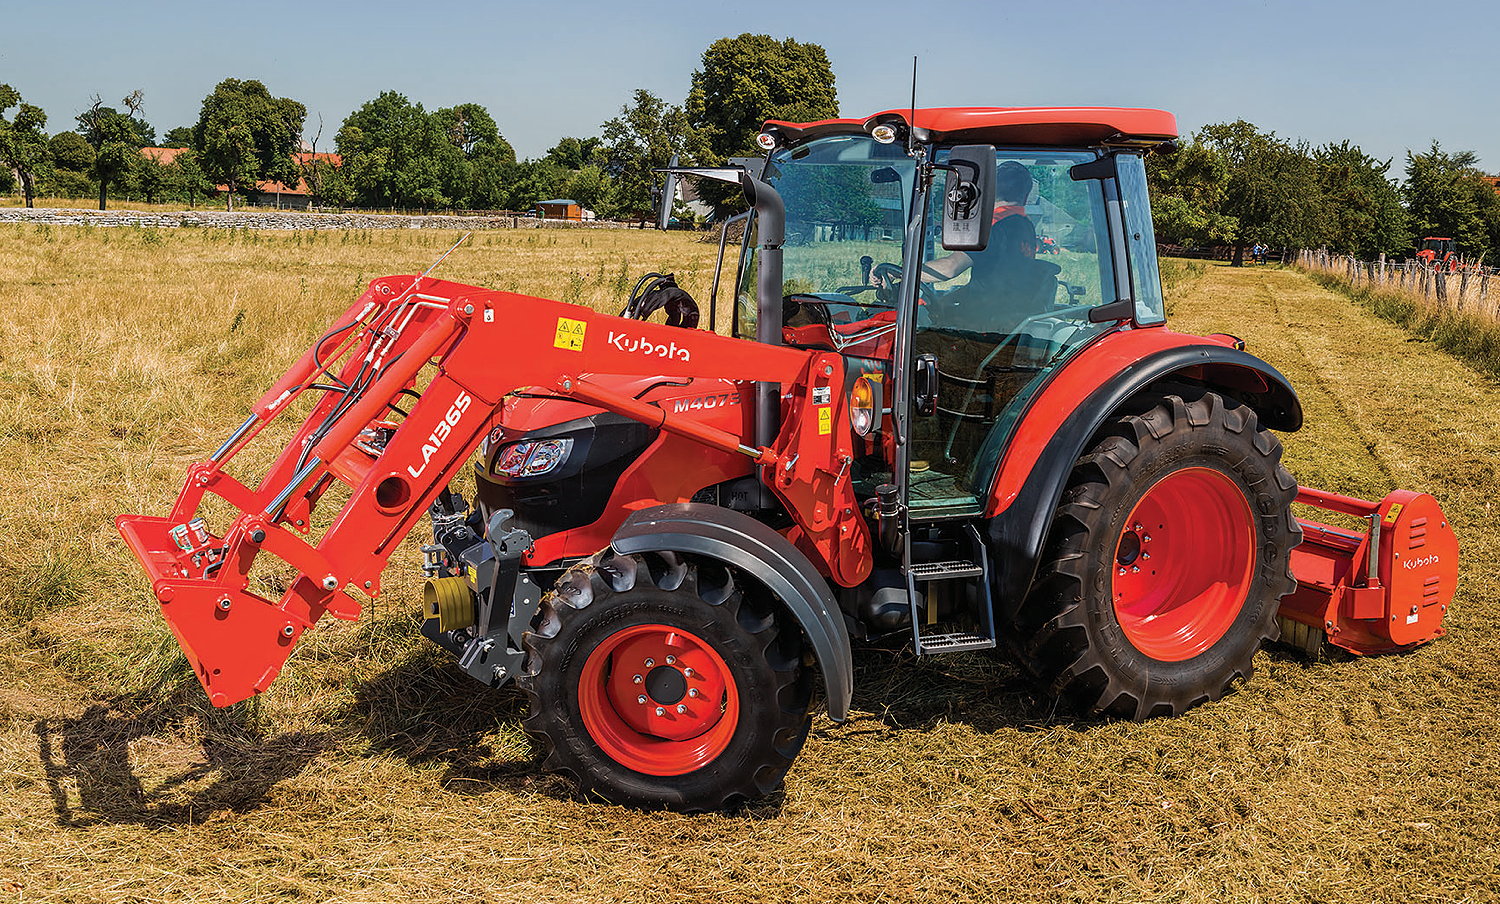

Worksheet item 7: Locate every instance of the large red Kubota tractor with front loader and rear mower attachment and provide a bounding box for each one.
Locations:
[117,108,1458,810]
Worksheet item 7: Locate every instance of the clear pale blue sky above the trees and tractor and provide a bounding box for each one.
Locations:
[0,0,1500,175]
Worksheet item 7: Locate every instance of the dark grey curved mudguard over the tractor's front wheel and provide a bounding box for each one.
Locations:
[611,502,854,723]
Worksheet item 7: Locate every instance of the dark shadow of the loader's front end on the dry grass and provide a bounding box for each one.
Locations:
[33,682,330,829]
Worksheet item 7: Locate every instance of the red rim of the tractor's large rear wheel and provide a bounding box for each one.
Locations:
[1112,468,1256,663]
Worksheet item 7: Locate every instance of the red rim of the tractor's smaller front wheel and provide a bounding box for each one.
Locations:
[578,625,740,775]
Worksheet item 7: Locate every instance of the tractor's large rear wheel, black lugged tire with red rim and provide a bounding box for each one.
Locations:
[1011,391,1302,721]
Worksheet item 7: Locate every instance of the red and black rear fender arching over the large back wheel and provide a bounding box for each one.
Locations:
[986,330,1302,615]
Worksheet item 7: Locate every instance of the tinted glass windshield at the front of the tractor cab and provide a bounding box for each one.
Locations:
[735,135,917,336]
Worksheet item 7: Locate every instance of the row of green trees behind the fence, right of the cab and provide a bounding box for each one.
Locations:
[1146,120,1500,264]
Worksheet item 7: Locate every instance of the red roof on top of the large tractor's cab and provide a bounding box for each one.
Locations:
[765,106,1178,147]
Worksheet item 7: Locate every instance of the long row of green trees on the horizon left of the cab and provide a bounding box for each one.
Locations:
[0,34,839,219]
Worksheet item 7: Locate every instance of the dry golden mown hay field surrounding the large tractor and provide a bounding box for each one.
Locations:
[0,233,1500,904]
